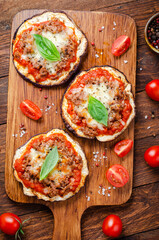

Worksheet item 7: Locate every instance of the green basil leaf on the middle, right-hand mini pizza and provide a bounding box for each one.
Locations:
[88,95,108,126]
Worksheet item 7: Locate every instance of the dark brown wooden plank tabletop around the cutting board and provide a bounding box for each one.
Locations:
[0,0,159,240]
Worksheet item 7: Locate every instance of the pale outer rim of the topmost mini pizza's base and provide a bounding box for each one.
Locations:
[12,11,88,87]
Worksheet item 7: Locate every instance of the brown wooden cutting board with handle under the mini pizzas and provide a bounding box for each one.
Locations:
[5,10,136,240]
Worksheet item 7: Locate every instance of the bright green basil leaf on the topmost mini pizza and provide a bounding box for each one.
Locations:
[33,34,61,62]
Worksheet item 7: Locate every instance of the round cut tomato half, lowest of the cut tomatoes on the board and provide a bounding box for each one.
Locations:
[106,164,129,187]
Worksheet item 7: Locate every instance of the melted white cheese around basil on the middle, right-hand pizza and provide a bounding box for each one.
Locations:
[74,81,119,130]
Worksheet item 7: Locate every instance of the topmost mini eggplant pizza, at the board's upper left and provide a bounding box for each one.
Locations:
[13,12,87,87]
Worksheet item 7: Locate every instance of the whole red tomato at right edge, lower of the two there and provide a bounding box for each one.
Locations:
[144,146,159,167]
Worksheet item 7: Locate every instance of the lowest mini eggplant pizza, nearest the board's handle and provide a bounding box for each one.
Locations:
[13,129,88,202]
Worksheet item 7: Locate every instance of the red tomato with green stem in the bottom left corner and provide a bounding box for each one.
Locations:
[0,213,22,235]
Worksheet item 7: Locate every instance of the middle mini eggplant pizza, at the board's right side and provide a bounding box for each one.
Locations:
[61,66,135,142]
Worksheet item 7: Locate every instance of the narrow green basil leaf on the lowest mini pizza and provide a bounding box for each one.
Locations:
[40,147,59,181]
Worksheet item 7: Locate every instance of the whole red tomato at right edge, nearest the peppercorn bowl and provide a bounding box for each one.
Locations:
[145,79,159,101]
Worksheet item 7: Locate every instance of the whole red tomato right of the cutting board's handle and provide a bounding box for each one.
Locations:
[102,214,122,237]
